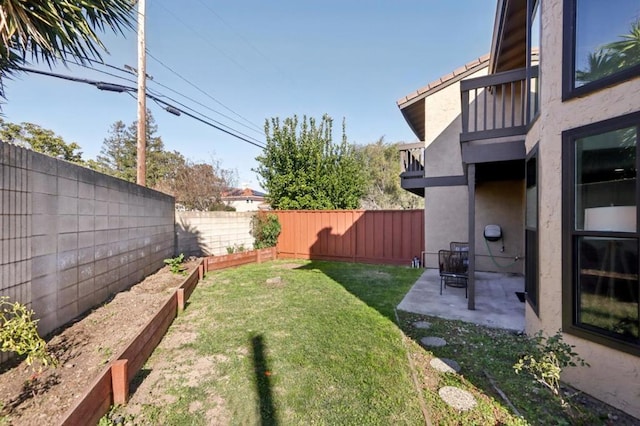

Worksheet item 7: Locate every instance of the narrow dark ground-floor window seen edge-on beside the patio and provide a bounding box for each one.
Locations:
[524,149,538,314]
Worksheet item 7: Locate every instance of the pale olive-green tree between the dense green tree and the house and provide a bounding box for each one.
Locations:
[356,138,423,210]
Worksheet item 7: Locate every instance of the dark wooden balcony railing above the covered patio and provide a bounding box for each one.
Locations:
[460,66,539,142]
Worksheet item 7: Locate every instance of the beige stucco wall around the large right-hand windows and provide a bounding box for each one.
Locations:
[526,0,640,418]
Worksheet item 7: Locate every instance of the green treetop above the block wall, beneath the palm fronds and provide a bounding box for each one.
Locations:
[0,118,83,163]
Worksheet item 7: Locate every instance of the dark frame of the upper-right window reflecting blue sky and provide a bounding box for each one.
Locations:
[562,0,640,101]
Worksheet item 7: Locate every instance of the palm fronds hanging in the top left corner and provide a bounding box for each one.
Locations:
[0,0,134,95]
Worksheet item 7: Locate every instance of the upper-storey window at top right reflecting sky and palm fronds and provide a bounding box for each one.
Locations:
[563,0,640,99]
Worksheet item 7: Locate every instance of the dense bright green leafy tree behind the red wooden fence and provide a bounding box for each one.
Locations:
[255,115,366,210]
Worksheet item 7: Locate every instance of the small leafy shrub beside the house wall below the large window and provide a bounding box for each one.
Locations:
[513,330,589,408]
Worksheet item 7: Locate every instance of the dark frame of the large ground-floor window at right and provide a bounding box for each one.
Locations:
[562,112,640,356]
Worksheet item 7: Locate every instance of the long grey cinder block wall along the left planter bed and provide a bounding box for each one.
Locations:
[0,142,175,334]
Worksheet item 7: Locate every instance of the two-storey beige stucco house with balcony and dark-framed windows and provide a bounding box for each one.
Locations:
[398,0,640,418]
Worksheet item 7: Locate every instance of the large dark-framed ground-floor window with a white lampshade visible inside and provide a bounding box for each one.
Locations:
[563,113,640,355]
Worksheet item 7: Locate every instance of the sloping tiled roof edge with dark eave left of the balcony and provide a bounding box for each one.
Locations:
[397,54,489,140]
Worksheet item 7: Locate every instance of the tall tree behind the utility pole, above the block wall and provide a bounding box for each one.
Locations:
[94,111,186,187]
